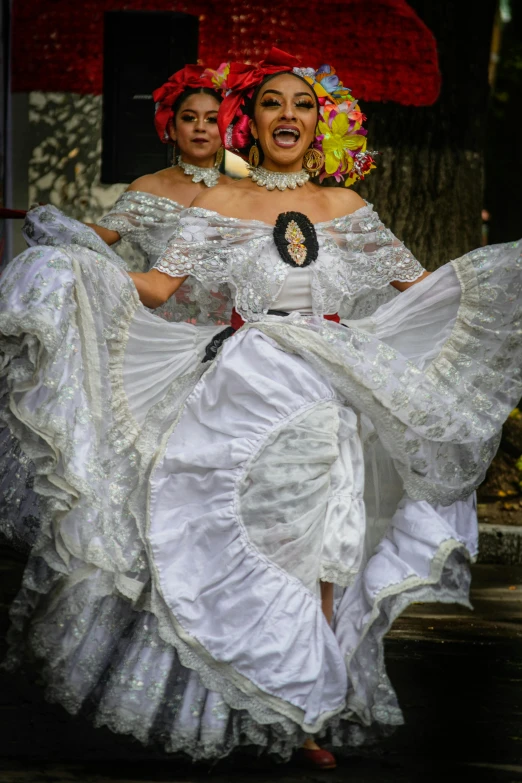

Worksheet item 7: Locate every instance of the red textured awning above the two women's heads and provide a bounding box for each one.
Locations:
[13,0,434,106]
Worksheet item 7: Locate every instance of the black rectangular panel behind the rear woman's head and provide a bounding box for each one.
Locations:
[102,11,198,184]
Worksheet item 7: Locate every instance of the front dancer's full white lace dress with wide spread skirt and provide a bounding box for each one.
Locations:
[0,201,522,759]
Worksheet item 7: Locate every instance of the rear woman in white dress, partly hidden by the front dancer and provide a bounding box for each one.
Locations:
[0,65,230,551]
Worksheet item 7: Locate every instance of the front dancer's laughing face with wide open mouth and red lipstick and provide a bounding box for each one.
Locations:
[250,73,318,171]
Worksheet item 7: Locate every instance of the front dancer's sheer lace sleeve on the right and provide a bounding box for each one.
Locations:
[324,204,425,296]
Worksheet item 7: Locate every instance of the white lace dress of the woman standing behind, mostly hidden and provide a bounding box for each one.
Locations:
[0,191,230,552]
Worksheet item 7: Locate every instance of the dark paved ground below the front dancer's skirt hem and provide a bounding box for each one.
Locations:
[0,554,522,783]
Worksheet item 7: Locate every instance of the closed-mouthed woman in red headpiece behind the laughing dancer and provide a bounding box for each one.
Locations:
[24,65,230,278]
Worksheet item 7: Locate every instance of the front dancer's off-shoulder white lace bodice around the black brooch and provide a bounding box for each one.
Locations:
[155,204,424,321]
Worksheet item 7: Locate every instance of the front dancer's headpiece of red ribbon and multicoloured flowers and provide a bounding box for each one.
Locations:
[206,47,377,187]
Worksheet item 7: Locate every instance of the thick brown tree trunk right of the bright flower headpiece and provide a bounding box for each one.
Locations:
[356,0,496,270]
